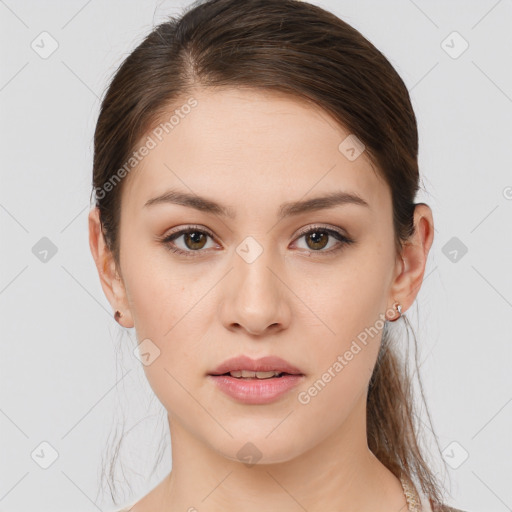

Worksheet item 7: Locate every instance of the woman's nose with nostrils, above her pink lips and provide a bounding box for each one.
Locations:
[220,244,293,336]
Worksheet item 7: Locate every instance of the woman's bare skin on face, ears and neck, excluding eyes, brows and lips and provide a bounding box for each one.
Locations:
[89,89,433,512]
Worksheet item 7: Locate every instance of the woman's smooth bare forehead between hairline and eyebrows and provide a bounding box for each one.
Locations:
[122,88,389,216]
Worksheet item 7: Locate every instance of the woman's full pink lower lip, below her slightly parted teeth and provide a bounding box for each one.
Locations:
[209,374,304,405]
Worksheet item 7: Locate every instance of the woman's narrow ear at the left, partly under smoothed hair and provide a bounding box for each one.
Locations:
[89,208,133,327]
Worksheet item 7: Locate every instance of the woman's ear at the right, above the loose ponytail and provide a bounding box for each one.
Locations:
[388,203,434,318]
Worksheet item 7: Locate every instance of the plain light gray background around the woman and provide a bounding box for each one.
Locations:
[0,0,512,512]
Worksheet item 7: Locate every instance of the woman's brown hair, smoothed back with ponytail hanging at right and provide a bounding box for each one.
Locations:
[93,0,448,510]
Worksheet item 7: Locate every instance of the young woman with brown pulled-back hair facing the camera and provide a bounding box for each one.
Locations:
[89,0,468,512]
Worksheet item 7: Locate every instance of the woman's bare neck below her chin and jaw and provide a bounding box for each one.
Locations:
[144,396,407,512]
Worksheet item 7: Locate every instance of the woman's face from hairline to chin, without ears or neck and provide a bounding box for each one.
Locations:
[99,89,403,463]
